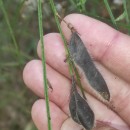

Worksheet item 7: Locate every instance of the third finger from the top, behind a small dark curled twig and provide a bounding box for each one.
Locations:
[23,60,70,112]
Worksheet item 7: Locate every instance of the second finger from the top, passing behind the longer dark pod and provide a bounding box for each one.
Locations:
[38,34,130,124]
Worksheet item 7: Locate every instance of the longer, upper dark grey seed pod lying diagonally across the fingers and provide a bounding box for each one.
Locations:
[69,32,110,101]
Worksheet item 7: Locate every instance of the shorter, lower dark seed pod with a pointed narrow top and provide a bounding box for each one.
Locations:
[69,77,94,130]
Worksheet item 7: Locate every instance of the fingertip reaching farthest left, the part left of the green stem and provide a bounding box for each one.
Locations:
[23,60,43,97]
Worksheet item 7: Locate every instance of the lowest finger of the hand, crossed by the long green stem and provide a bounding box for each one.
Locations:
[31,99,67,130]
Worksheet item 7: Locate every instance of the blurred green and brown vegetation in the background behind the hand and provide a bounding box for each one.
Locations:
[0,0,130,130]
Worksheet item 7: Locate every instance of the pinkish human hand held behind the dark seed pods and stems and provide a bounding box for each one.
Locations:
[23,14,130,130]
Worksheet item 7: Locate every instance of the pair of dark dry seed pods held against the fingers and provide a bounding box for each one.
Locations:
[69,32,110,130]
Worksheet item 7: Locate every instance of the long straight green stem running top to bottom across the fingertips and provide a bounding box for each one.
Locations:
[38,0,52,130]
